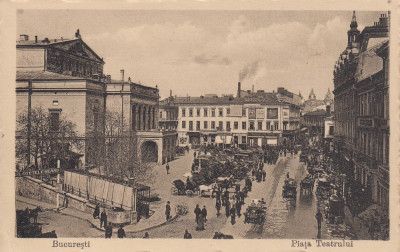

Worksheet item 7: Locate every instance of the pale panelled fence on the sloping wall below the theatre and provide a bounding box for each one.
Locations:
[63,171,137,211]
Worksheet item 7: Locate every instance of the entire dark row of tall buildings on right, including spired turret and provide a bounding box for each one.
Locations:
[334,12,389,212]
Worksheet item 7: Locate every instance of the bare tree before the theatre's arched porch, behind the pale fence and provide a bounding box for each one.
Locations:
[91,111,155,184]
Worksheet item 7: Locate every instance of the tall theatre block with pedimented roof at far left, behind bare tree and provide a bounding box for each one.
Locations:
[16,31,105,168]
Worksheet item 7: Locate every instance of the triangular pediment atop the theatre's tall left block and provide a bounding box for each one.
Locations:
[52,39,103,62]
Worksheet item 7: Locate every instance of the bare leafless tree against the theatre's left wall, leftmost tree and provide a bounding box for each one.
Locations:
[15,107,83,169]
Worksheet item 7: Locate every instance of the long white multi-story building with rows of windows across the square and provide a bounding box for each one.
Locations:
[175,84,300,146]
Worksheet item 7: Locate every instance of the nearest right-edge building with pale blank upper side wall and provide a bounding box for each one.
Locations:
[355,14,389,208]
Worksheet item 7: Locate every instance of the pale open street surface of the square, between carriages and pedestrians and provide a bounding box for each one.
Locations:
[16,151,354,239]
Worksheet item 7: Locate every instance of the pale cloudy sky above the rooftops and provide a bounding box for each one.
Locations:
[16,10,381,99]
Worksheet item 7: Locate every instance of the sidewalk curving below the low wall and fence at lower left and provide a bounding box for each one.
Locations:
[16,195,177,233]
